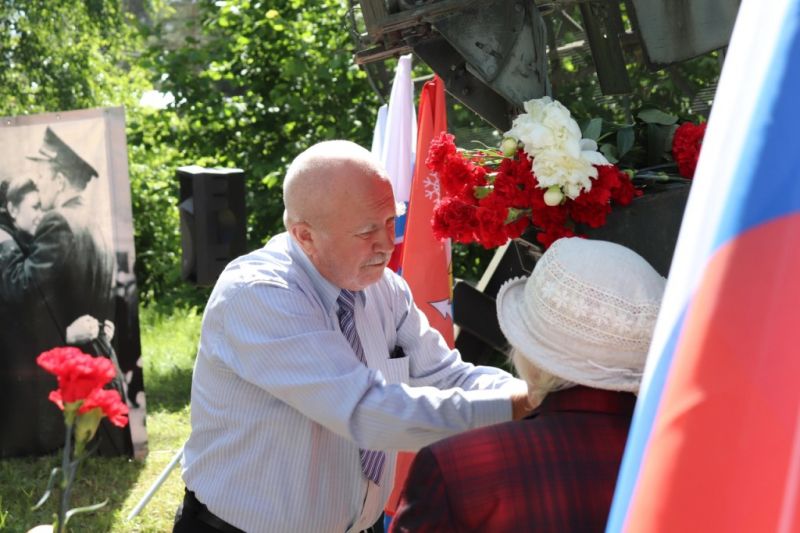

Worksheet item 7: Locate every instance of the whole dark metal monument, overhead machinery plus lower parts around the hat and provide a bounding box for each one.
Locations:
[349,0,739,363]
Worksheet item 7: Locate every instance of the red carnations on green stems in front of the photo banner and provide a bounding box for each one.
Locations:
[35,347,128,533]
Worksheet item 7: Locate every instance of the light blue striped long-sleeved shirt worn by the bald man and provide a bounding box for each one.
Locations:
[183,233,525,533]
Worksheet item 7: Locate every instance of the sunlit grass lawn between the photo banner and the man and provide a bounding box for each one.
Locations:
[0,309,201,533]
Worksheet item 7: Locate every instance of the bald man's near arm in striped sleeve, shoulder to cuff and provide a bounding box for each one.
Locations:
[212,281,511,450]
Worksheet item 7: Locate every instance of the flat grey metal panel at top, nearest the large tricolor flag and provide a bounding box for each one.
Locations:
[629,0,736,65]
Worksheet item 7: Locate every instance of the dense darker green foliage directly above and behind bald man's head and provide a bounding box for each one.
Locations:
[151,0,377,249]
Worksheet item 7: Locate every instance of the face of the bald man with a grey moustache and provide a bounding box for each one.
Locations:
[311,178,396,291]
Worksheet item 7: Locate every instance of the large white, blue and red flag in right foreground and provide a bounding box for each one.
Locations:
[607,0,800,533]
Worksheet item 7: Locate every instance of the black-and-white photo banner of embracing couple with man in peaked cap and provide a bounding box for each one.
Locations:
[0,108,147,458]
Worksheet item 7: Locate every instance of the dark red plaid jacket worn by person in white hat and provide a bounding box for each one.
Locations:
[390,387,636,533]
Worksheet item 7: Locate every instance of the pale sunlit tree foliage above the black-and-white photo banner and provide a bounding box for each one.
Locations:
[0,0,146,115]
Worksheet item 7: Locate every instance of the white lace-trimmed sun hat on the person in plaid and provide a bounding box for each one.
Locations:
[497,237,666,392]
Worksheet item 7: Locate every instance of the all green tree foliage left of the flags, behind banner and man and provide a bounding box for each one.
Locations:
[0,0,384,302]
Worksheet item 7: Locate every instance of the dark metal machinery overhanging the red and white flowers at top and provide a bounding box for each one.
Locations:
[351,0,739,130]
